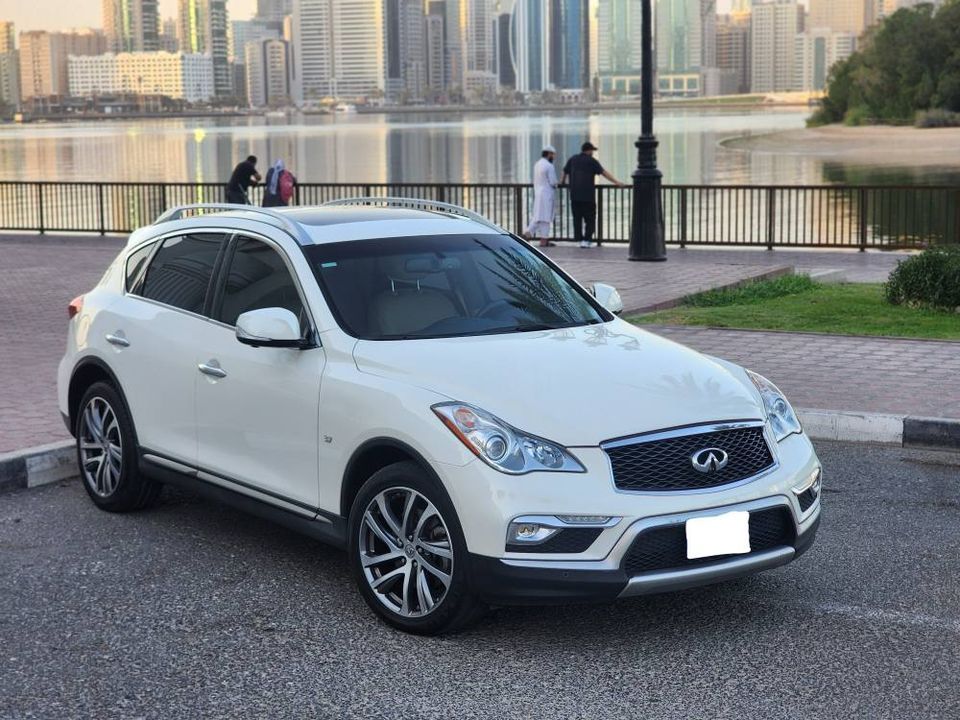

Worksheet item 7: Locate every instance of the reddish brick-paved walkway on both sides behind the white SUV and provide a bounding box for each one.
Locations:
[0,235,928,452]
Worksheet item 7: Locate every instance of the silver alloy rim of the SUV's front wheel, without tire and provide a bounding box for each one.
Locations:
[359,487,453,617]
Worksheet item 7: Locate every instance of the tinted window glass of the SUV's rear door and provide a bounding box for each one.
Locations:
[139,233,223,314]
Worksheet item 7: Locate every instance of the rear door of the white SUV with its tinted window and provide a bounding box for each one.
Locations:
[98,232,227,465]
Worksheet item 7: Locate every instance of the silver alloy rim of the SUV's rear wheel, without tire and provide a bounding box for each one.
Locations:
[77,397,123,498]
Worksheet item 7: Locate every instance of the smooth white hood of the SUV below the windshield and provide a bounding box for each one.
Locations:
[354,320,764,447]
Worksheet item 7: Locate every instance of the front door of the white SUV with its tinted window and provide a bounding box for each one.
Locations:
[197,236,324,512]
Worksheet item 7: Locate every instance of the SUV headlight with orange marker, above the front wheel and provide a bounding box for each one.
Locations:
[431,403,586,475]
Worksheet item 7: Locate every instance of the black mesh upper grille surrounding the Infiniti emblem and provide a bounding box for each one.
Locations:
[602,422,776,492]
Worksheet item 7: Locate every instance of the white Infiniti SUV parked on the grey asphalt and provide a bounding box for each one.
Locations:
[58,199,821,633]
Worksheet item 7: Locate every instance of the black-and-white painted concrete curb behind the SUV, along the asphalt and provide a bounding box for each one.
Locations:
[0,410,960,493]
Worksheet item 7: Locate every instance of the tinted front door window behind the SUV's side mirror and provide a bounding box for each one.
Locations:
[216,238,305,325]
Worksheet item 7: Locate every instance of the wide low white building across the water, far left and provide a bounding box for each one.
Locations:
[68,51,213,102]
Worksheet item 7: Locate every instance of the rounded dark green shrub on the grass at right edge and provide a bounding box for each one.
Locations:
[883,245,960,310]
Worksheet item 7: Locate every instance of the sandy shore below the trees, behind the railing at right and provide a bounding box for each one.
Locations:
[723,125,960,167]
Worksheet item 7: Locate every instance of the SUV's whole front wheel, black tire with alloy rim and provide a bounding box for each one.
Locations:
[347,462,486,635]
